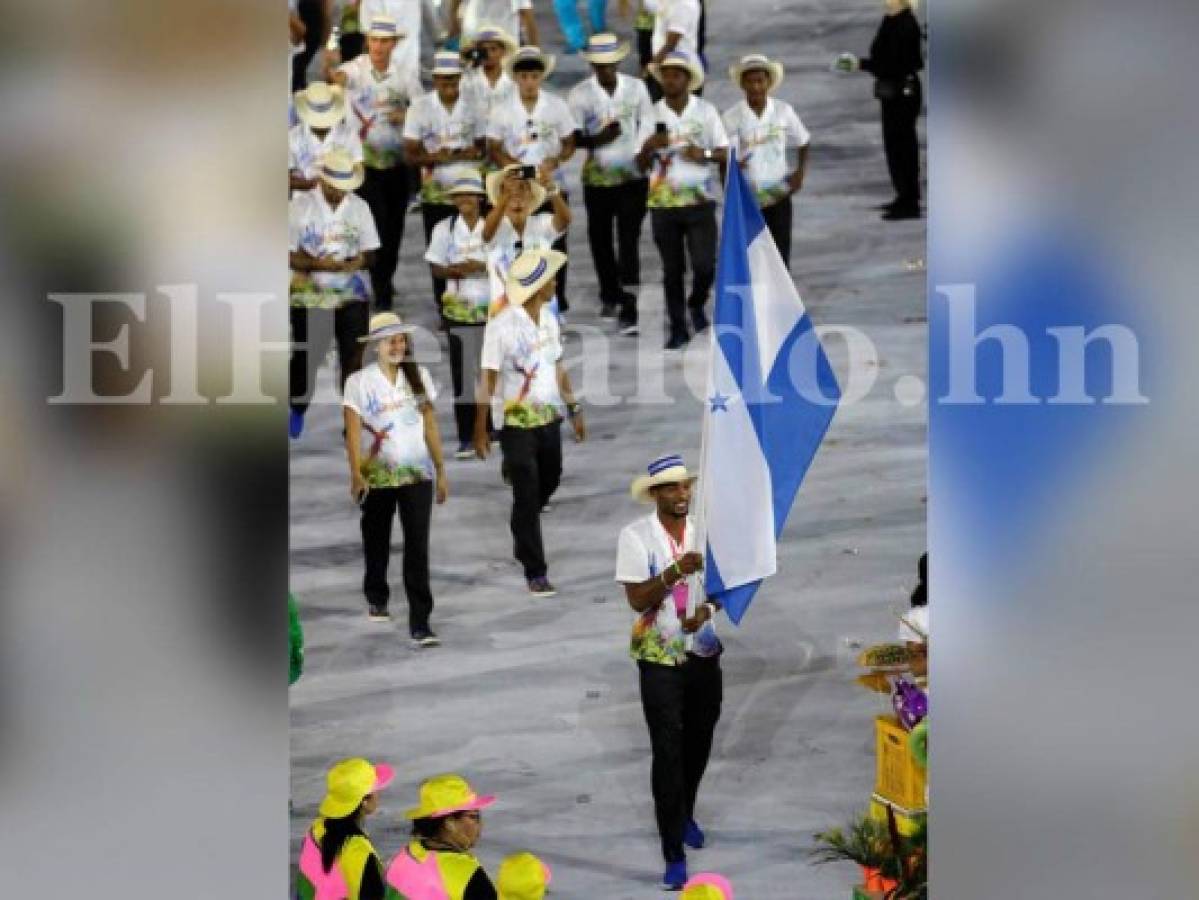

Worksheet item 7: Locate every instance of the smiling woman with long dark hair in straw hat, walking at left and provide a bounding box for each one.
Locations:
[342,313,448,647]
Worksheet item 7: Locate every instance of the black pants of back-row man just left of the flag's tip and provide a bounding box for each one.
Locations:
[652,203,716,338]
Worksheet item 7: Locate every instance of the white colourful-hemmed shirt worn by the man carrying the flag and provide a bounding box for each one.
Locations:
[616,512,721,665]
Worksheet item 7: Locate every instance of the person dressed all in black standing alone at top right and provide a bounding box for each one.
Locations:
[837,0,924,221]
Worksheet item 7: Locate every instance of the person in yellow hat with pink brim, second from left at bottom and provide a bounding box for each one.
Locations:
[386,775,496,900]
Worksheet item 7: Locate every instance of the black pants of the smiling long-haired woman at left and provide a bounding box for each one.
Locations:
[361,482,433,630]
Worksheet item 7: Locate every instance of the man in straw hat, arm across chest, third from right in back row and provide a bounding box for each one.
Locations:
[567,34,653,334]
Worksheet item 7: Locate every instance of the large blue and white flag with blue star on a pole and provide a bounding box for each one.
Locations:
[700,156,840,623]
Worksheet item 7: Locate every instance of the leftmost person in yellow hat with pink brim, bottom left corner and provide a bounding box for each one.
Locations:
[296,759,394,900]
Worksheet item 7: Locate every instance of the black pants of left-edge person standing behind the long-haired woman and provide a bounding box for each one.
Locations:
[288,301,370,413]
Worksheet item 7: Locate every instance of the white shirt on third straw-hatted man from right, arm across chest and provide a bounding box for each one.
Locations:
[567,74,653,187]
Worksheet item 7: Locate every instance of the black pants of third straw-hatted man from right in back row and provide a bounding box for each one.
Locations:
[583,179,650,303]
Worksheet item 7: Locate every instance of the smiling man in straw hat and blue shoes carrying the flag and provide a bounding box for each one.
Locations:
[616,455,723,890]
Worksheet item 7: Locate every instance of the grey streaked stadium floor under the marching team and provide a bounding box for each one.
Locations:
[290,0,927,900]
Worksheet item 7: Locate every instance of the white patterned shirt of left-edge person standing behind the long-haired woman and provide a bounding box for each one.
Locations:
[288,187,379,309]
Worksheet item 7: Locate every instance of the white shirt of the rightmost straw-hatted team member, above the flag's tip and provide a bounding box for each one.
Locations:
[724,97,812,207]
